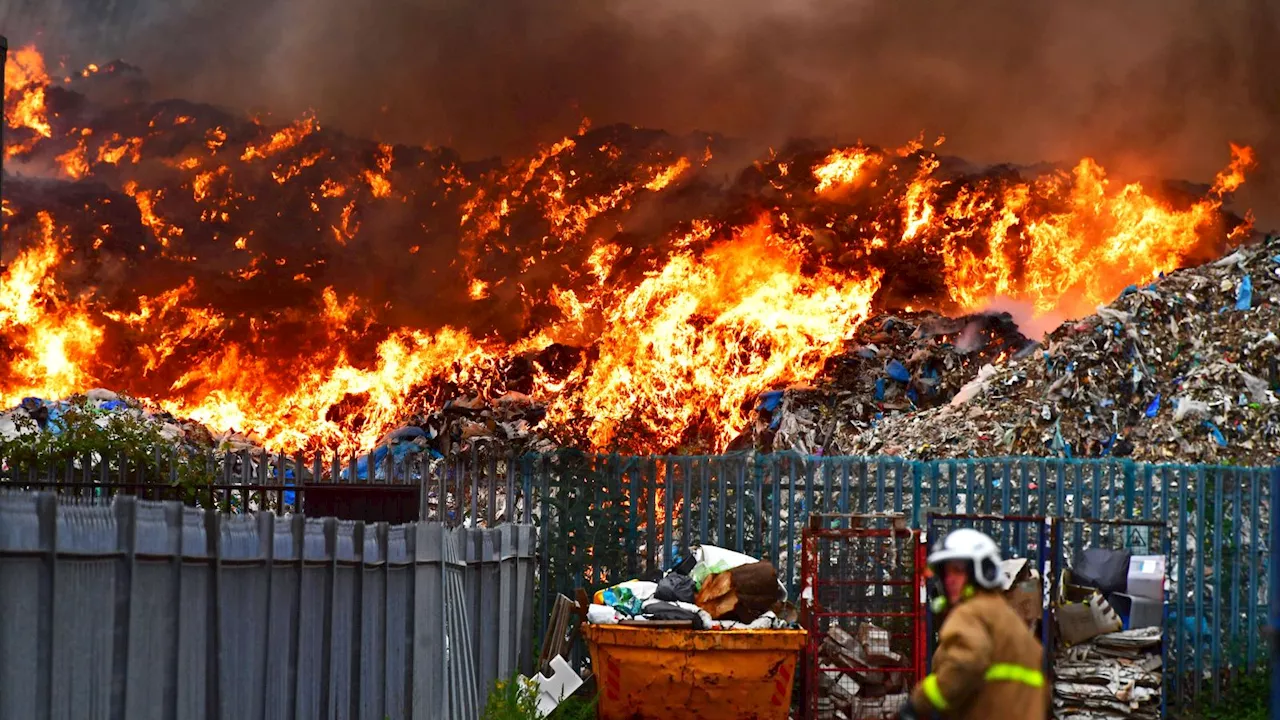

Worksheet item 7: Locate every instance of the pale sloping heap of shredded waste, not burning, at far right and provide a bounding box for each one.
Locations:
[832,236,1280,466]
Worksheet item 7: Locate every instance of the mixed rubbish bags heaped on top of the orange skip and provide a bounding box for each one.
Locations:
[586,544,796,630]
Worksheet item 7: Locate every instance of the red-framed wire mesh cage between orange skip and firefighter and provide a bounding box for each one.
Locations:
[800,514,924,720]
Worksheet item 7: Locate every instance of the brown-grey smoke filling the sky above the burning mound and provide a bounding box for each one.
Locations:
[0,0,1280,223]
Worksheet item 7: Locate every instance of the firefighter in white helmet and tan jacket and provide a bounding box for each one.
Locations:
[899,529,1050,720]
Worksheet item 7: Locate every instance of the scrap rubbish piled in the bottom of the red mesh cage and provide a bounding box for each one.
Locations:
[818,623,911,720]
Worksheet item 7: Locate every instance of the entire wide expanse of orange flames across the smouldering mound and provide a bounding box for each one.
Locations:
[0,49,1256,452]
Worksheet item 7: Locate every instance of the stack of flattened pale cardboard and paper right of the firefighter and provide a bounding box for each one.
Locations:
[1053,628,1161,720]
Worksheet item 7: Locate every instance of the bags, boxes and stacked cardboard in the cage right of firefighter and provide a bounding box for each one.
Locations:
[1053,548,1165,720]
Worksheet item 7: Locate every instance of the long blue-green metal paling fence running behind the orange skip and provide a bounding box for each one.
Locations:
[0,445,1272,707]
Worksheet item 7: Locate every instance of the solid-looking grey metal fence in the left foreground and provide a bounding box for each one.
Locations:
[0,492,534,720]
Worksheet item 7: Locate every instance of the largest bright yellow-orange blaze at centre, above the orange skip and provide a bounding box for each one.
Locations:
[537,223,878,447]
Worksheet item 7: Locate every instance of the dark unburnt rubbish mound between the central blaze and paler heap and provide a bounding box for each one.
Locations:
[730,311,1037,455]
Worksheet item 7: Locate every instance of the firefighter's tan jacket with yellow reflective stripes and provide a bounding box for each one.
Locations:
[911,592,1050,720]
